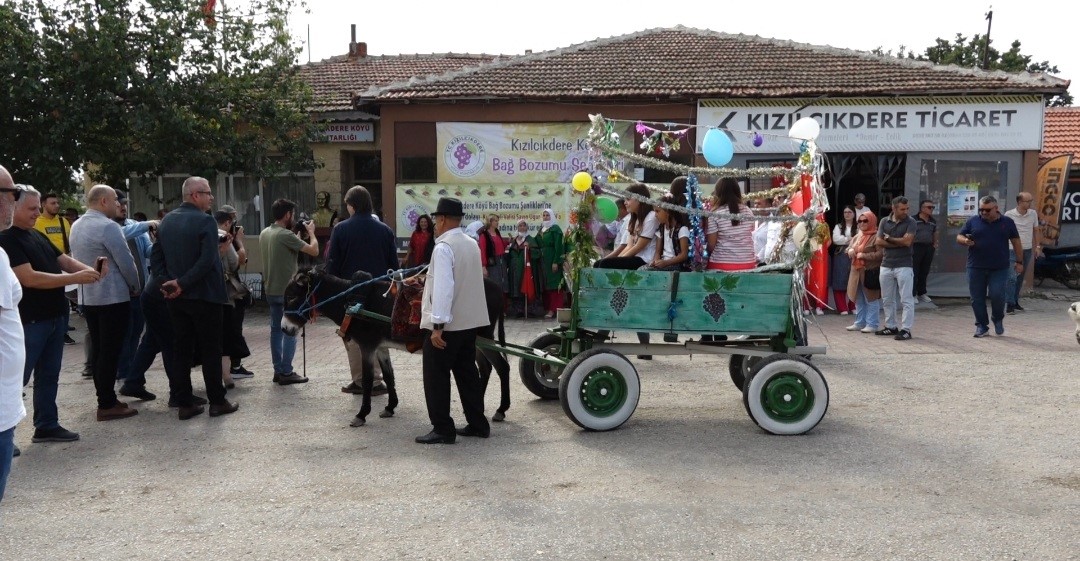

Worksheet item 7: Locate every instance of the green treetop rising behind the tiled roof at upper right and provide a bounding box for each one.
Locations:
[873,34,1072,107]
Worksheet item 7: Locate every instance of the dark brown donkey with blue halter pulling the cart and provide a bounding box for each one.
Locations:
[281,267,510,427]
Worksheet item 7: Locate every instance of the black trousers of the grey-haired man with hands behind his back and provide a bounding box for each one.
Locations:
[168,298,225,405]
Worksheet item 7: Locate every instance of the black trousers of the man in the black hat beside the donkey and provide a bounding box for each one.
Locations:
[423,330,491,436]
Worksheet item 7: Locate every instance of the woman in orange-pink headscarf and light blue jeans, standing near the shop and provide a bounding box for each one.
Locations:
[846,211,885,333]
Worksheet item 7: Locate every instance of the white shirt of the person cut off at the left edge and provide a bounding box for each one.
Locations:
[0,250,26,431]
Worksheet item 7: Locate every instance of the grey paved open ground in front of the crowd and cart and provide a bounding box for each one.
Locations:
[0,292,1080,560]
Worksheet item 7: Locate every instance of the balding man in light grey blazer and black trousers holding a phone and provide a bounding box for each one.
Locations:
[71,185,143,420]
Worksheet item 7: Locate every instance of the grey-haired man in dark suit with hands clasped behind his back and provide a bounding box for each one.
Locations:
[150,177,240,420]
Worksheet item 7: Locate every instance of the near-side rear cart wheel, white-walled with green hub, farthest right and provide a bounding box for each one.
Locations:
[743,355,828,435]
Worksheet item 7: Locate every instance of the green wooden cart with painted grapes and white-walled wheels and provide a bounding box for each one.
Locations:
[481,269,828,435]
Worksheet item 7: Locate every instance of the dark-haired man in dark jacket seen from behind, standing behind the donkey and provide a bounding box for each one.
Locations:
[326,185,399,396]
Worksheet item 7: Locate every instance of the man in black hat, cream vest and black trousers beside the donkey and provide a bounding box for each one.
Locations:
[416,197,491,444]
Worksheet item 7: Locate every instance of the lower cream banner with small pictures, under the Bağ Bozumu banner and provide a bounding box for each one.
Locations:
[396,183,573,239]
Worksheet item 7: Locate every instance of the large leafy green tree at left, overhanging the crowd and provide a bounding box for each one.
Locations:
[0,0,318,189]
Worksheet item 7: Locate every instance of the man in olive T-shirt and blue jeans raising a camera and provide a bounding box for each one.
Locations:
[259,199,319,386]
